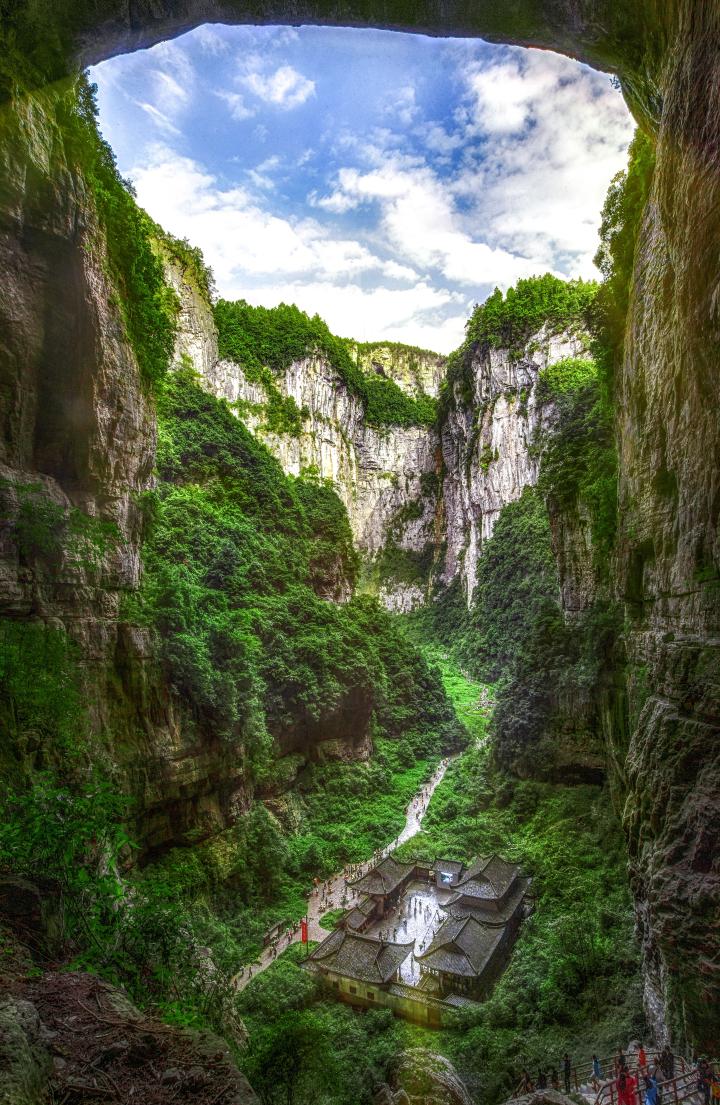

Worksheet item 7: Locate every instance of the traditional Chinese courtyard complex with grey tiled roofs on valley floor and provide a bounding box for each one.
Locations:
[308,855,530,1027]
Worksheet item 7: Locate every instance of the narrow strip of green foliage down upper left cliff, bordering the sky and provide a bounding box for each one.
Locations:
[62,77,178,390]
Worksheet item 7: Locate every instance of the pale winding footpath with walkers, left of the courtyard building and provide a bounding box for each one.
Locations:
[233,757,454,991]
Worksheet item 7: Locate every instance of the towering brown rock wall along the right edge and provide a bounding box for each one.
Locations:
[607,3,720,1051]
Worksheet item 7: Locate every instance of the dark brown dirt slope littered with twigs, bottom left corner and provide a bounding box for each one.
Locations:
[0,923,257,1105]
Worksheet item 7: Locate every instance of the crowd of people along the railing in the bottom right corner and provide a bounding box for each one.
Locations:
[518,1043,720,1105]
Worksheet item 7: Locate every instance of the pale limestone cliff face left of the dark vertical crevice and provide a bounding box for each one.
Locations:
[167,270,445,611]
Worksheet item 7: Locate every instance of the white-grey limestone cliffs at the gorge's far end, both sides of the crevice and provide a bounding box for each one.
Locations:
[168,267,586,612]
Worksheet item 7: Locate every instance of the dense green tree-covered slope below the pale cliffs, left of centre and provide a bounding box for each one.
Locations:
[136,372,459,764]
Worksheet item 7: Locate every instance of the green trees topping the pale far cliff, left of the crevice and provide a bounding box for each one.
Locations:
[214,299,436,433]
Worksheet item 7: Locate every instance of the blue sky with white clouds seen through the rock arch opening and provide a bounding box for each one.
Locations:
[89,25,633,352]
